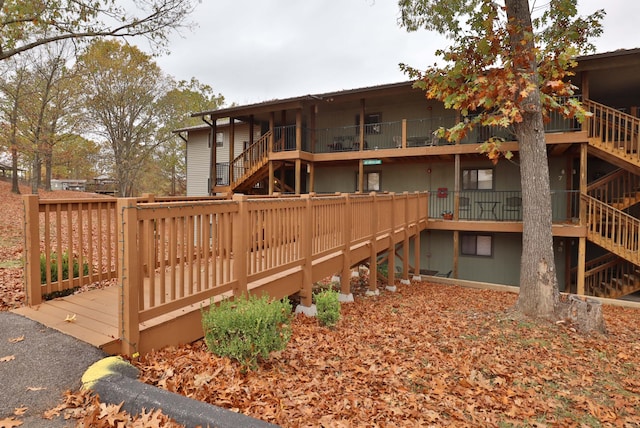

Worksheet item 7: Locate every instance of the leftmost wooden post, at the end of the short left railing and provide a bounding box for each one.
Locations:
[22,195,42,306]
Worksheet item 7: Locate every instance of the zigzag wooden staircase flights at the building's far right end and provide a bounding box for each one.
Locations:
[581,100,640,298]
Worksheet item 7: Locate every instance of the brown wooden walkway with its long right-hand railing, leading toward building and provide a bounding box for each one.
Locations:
[21,193,428,355]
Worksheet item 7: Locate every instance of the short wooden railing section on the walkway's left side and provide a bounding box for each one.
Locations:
[23,195,118,305]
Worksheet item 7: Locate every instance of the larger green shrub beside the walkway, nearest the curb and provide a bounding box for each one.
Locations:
[202,295,291,369]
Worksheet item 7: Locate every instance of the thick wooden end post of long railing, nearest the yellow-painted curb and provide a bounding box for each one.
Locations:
[117,198,142,356]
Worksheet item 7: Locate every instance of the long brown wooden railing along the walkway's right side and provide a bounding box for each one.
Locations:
[118,193,428,353]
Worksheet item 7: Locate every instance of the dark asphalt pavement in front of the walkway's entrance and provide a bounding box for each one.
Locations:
[0,312,105,428]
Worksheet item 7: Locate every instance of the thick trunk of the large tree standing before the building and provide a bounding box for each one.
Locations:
[505,0,559,319]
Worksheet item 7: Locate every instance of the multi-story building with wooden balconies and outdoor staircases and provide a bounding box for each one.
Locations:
[183,49,640,297]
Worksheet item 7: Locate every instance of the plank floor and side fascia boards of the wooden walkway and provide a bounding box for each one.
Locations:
[12,224,420,354]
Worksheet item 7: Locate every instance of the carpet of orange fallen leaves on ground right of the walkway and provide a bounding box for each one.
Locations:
[134,283,640,427]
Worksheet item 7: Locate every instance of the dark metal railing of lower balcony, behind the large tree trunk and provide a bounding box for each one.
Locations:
[429,189,580,223]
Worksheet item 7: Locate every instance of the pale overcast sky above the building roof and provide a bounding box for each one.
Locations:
[156,0,640,105]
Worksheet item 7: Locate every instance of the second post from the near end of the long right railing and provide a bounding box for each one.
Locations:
[231,194,248,297]
